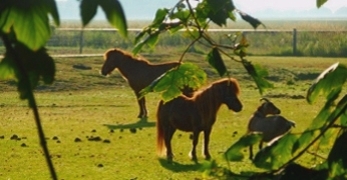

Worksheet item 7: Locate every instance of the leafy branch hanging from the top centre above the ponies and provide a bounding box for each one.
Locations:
[133,0,272,99]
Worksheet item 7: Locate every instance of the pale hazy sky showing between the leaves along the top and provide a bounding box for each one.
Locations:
[56,0,347,20]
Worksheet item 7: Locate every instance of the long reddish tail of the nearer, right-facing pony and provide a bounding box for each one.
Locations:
[157,101,166,157]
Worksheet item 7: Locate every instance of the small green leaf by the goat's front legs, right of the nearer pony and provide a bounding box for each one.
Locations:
[224,133,262,161]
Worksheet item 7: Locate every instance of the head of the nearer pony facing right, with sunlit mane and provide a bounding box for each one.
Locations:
[217,78,243,112]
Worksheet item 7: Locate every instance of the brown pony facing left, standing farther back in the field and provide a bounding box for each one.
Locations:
[101,48,179,118]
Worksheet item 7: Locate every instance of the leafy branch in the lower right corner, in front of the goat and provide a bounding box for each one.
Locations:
[224,63,347,179]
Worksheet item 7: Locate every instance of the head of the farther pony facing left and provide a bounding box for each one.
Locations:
[101,49,123,76]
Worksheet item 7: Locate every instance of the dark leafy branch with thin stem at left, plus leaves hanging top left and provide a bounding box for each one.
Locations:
[0,0,127,179]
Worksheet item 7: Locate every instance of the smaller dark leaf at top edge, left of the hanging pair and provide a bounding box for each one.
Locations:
[80,0,98,26]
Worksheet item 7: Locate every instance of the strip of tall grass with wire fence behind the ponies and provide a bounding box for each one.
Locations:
[0,28,347,57]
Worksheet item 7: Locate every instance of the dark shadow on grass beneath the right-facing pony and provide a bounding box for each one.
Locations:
[158,158,202,172]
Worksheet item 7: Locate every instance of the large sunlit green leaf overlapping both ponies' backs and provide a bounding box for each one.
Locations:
[141,63,206,102]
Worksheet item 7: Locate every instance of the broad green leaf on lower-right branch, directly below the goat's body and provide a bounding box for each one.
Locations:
[253,133,297,170]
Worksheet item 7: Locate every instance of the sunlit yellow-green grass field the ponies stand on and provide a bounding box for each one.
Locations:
[0,53,347,180]
